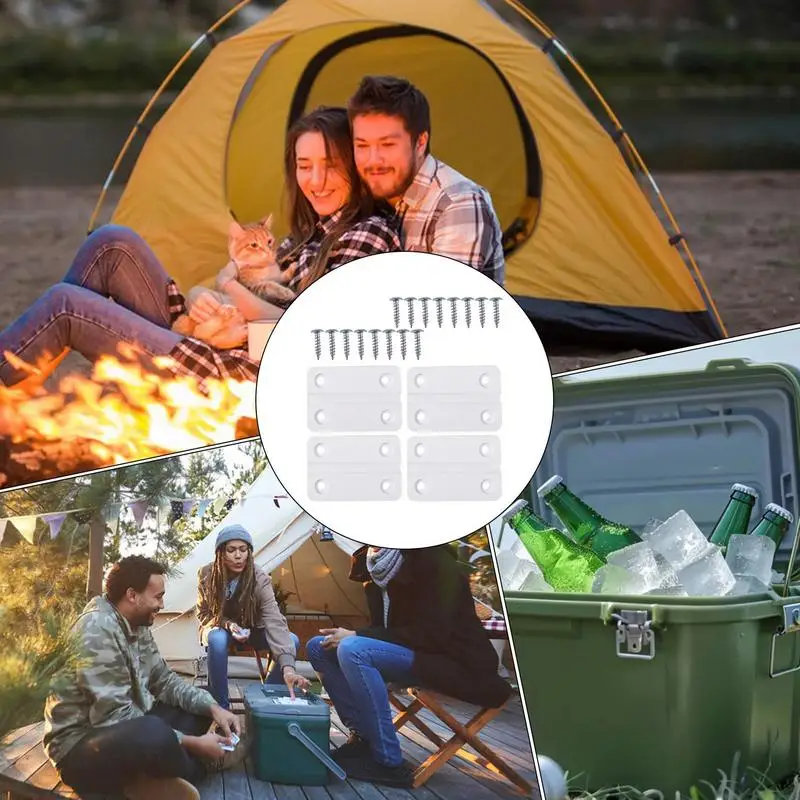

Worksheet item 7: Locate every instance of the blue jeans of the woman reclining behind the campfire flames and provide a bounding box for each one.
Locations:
[0,225,181,386]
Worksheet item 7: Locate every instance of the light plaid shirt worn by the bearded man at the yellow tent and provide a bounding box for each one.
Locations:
[397,155,505,286]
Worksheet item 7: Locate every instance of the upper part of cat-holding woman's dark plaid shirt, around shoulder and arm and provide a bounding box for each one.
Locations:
[277,211,403,292]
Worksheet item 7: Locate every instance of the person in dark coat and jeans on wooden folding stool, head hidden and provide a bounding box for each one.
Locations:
[306,545,511,787]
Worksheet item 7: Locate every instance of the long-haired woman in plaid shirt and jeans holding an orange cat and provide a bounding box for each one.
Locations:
[0,107,402,386]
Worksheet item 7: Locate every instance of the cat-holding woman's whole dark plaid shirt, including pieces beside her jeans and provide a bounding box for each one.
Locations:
[162,211,402,388]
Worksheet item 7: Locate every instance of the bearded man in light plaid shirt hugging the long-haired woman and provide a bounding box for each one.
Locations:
[348,76,505,286]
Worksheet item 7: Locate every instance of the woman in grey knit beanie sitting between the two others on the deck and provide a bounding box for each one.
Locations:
[197,525,309,708]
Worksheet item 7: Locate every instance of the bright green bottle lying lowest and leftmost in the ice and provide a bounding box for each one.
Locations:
[503,500,605,592]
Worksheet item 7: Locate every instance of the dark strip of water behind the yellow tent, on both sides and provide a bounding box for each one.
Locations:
[0,97,800,187]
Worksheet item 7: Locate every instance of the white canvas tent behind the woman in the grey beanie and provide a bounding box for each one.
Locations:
[153,466,366,674]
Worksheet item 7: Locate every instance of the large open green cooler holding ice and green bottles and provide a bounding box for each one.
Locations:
[504,360,800,797]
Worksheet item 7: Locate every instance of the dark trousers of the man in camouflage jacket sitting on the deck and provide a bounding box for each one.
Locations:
[59,703,211,796]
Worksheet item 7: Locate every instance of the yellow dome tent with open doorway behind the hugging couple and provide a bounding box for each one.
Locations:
[101,0,725,351]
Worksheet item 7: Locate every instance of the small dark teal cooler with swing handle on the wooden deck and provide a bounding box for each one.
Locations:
[244,684,347,786]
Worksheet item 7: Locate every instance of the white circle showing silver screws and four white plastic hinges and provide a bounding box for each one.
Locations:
[256,252,553,549]
